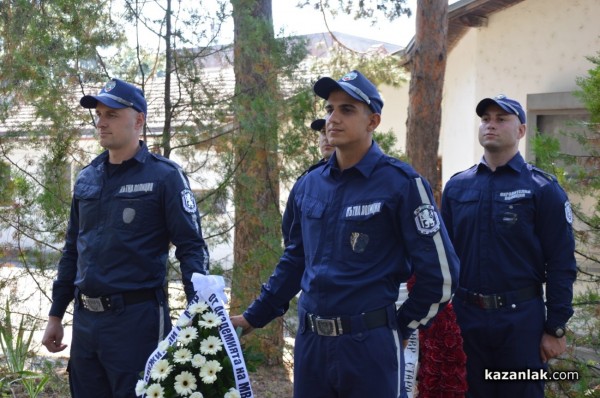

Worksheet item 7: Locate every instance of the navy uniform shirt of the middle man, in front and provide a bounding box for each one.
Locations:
[244,143,458,338]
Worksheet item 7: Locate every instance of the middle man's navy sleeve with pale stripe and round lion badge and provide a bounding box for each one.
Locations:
[397,177,459,339]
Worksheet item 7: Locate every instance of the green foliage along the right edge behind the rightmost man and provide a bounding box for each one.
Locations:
[532,50,600,398]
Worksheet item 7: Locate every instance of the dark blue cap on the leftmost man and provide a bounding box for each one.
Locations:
[79,79,148,116]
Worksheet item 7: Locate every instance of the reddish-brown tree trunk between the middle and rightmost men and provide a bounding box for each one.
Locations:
[406,0,448,204]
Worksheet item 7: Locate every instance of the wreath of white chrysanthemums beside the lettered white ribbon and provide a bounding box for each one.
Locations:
[135,302,240,398]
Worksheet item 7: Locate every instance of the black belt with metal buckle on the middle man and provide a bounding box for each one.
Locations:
[306,308,388,336]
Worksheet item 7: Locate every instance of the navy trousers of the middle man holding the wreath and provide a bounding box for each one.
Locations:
[294,311,406,398]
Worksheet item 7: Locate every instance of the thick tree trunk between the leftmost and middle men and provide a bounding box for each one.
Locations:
[231,0,283,365]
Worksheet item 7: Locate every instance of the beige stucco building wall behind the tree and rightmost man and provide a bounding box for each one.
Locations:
[390,0,600,182]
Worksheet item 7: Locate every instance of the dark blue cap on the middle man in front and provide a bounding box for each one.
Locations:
[313,70,383,113]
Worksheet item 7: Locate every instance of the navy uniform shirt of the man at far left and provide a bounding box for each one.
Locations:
[50,142,208,317]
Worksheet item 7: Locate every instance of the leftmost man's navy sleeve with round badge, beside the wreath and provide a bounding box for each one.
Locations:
[164,168,209,301]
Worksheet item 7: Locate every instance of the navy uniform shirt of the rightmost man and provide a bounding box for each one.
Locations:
[442,153,576,327]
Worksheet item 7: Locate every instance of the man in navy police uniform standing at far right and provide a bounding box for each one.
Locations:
[442,95,576,398]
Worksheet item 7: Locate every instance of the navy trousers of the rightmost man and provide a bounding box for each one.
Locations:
[453,297,547,398]
